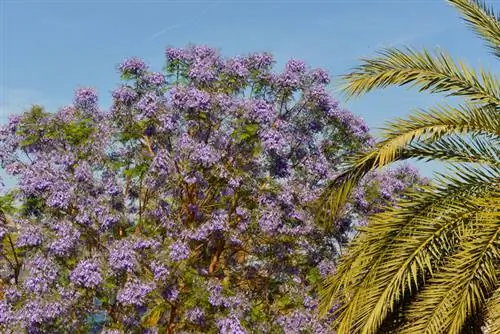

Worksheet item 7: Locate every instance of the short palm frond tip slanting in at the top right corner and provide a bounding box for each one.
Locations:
[448,0,500,57]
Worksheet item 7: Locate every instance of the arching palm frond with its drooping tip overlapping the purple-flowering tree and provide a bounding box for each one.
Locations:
[319,104,500,223]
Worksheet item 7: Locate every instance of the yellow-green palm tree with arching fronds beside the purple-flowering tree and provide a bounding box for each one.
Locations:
[321,0,500,334]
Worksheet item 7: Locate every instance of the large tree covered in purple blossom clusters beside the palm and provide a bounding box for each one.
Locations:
[0,46,418,333]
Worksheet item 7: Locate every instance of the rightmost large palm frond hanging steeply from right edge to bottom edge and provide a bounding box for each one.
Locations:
[402,190,500,334]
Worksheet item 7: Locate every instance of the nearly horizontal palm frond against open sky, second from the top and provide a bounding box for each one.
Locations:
[344,48,500,105]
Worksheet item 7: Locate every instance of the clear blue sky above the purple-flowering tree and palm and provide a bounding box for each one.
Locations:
[0,0,500,175]
